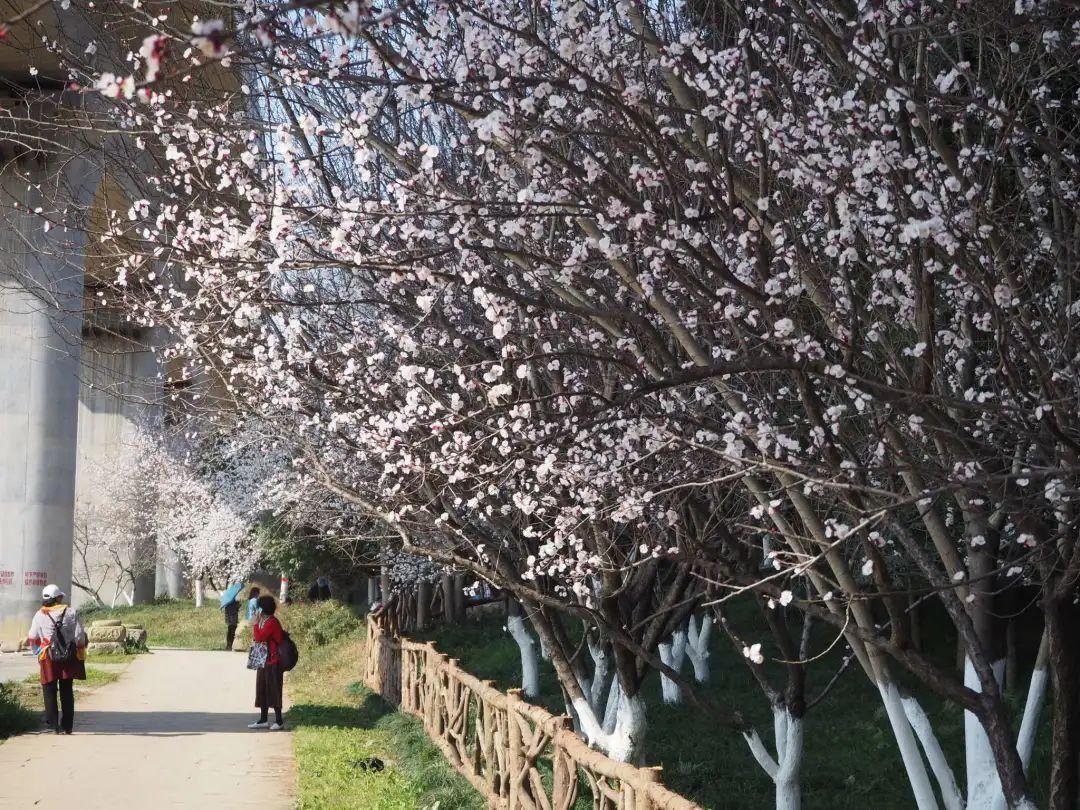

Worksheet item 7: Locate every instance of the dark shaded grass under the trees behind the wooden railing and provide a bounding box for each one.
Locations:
[427,617,1049,810]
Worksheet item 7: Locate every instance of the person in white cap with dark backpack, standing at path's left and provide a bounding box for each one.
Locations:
[26,585,86,734]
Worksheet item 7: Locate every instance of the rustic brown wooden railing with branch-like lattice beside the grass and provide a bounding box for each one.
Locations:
[364,622,702,810]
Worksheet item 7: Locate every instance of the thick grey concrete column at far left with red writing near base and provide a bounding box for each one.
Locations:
[0,153,83,640]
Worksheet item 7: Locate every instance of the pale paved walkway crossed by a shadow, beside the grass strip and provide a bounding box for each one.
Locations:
[0,650,295,810]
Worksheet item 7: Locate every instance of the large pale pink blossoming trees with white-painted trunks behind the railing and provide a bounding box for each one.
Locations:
[8,0,1080,808]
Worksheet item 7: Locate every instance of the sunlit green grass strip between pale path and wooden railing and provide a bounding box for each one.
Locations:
[287,634,485,810]
